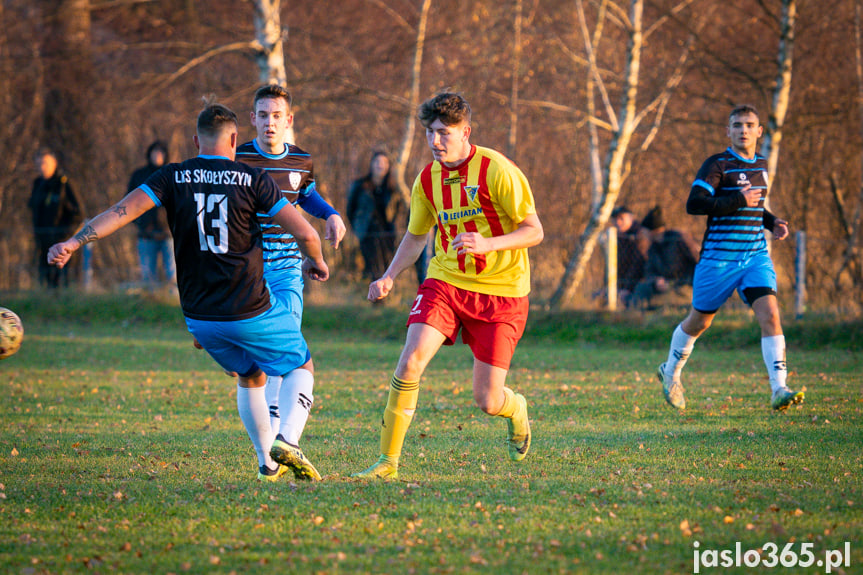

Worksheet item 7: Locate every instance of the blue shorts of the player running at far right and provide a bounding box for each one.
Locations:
[692,253,776,313]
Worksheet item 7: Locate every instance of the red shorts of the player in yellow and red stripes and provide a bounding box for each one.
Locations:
[407,279,529,369]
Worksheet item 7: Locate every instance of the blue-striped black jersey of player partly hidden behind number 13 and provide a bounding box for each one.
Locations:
[237,140,315,283]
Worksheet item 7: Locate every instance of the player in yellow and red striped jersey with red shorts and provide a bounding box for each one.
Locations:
[355,93,543,479]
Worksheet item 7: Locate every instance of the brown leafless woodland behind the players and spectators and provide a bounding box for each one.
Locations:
[0,0,863,313]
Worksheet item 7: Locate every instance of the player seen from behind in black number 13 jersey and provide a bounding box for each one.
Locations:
[48,104,329,480]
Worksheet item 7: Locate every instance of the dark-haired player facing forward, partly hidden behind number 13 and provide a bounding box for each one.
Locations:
[237,84,346,481]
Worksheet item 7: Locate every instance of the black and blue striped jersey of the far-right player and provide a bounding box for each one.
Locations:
[686,147,776,261]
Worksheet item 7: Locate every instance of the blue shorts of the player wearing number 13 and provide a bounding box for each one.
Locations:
[186,297,312,377]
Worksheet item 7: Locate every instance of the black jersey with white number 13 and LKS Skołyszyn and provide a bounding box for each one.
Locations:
[140,156,287,321]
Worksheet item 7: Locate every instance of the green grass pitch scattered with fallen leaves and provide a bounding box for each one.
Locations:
[0,294,863,575]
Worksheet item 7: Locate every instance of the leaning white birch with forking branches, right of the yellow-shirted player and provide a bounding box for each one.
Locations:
[549,0,704,309]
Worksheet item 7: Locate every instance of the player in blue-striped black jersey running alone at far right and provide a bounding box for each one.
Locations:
[659,105,803,410]
